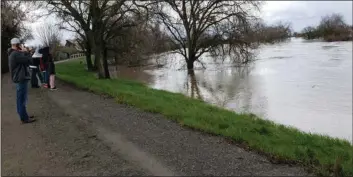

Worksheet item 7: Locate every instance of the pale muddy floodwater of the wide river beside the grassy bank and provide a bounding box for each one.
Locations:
[112,39,352,141]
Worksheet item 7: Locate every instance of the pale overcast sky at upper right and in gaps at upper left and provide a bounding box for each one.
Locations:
[26,1,352,45]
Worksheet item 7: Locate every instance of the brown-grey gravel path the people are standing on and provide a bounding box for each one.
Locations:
[1,73,307,176]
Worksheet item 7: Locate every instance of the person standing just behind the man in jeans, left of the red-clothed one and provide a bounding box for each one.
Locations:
[29,48,44,88]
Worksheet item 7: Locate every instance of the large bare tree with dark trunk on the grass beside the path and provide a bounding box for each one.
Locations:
[39,0,153,78]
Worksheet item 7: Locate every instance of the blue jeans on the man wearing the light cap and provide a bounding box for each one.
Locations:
[16,81,28,121]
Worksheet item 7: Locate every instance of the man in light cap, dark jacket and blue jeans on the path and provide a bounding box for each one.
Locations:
[8,38,35,123]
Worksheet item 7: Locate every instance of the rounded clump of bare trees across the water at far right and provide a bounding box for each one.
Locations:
[295,14,353,42]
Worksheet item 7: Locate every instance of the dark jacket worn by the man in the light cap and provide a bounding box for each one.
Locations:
[8,48,32,83]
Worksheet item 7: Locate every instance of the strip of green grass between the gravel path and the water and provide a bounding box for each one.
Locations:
[57,61,353,176]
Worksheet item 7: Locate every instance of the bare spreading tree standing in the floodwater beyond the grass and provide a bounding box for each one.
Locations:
[156,0,259,70]
